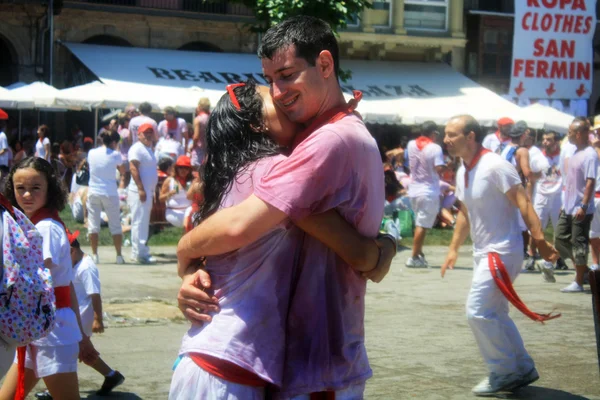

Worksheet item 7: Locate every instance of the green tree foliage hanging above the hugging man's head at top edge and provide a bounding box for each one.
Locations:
[235,0,371,32]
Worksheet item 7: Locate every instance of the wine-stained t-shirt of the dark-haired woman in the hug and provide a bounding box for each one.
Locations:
[180,156,304,386]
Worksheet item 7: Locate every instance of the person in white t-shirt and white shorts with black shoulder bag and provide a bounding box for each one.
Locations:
[86,130,125,264]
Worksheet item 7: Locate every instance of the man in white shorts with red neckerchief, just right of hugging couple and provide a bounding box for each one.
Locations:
[406,121,445,268]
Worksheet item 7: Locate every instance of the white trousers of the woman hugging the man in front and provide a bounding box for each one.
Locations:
[169,356,265,400]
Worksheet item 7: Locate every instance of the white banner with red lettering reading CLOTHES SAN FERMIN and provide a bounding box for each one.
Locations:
[509,0,596,99]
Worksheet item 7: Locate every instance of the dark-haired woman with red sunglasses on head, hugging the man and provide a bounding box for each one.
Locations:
[169,81,395,400]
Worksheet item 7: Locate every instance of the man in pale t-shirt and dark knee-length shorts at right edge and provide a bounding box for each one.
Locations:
[555,118,598,293]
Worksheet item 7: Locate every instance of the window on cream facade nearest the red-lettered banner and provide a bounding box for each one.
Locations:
[404,0,448,31]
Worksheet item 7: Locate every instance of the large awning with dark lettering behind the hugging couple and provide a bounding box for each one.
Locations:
[65,43,534,124]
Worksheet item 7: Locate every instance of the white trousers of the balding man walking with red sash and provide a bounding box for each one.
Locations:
[467,251,534,375]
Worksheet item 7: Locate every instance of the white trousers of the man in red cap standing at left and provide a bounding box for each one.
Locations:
[127,188,154,259]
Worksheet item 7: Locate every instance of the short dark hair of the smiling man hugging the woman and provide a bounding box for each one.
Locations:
[258,15,340,78]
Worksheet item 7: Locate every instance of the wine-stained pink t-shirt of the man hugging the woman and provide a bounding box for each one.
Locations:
[254,115,385,396]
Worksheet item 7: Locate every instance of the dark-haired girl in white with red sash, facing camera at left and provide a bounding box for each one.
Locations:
[0,157,98,400]
